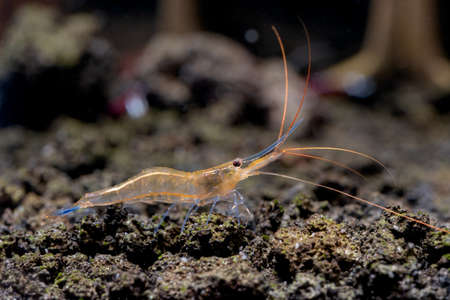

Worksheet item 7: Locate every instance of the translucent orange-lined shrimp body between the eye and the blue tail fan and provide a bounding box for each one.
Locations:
[71,162,243,208]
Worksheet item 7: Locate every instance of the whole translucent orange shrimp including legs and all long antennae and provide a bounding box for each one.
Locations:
[54,20,450,233]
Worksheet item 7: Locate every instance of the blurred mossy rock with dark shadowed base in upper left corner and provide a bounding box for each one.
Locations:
[0,4,115,129]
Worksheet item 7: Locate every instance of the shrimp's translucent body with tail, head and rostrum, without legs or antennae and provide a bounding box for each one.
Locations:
[56,125,288,215]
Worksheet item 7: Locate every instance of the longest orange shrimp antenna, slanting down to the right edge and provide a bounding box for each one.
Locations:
[253,171,450,234]
